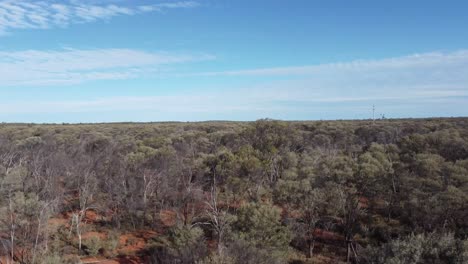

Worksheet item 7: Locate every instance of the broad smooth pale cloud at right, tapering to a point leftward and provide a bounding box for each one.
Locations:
[182,50,468,106]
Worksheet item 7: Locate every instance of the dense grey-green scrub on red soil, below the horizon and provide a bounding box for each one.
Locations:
[0,118,468,264]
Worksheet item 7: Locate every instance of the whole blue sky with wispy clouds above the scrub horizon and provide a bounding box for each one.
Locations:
[0,0,468,123]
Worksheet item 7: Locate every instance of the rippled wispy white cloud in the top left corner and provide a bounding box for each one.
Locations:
[0,0,199,34]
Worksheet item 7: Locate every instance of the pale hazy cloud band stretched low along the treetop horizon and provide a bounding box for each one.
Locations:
[0,89,468,117]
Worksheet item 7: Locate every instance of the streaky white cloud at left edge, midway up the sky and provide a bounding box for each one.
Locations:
[0,49,214,84]
